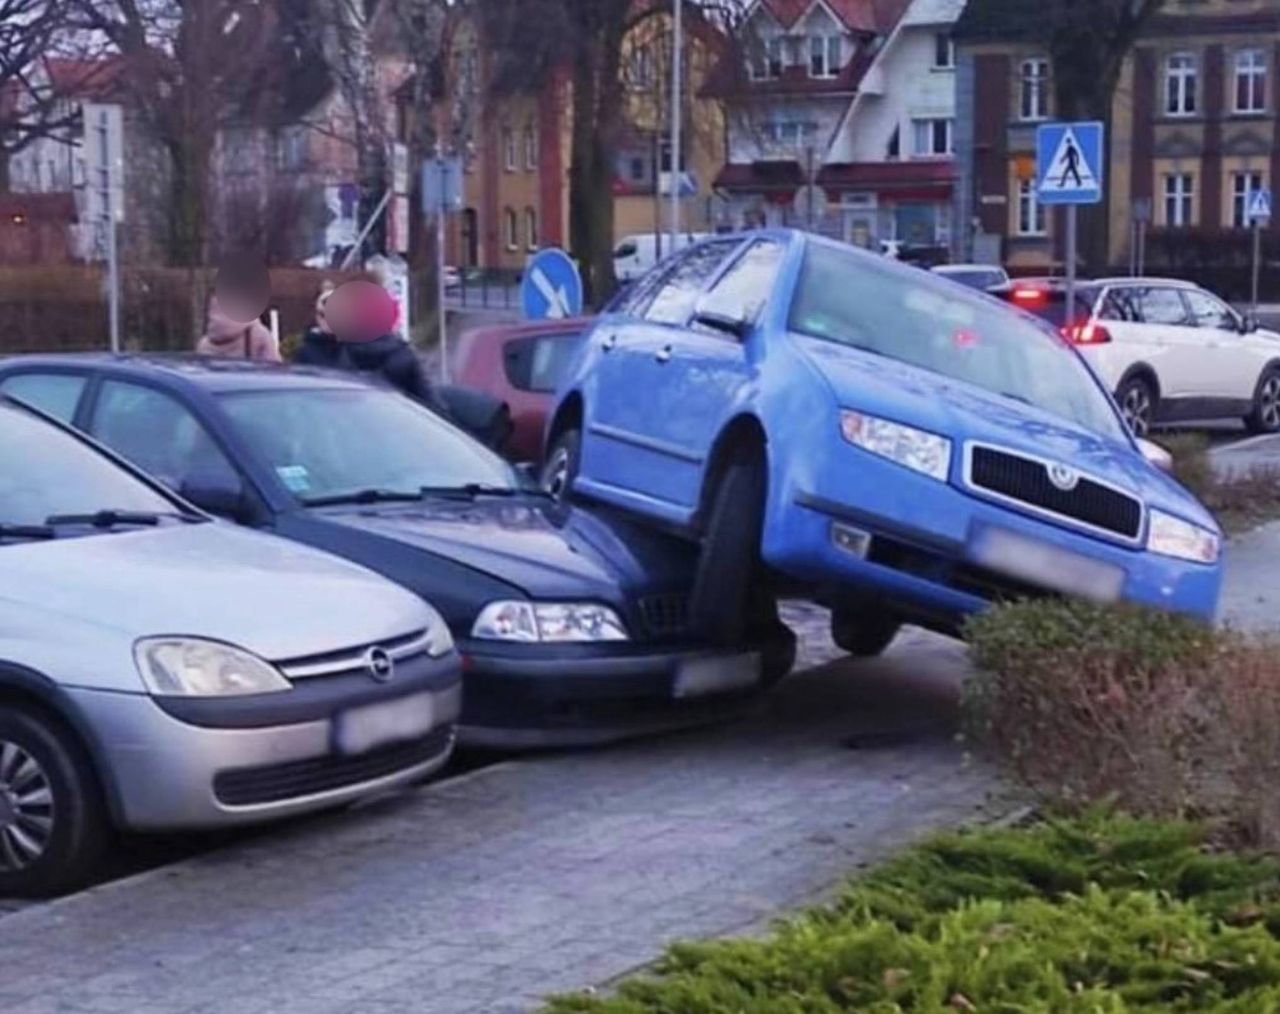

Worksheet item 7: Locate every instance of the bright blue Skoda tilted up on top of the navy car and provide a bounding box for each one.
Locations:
[544,230,1222,654]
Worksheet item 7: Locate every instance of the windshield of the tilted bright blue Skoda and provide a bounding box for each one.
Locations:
[788,243,1125,439]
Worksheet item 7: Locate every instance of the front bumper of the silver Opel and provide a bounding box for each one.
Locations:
[68,658,462,831]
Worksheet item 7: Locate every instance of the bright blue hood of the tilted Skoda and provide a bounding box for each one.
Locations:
[796,335,1217,530]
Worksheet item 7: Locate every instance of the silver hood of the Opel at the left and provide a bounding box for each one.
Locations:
[0,521,431,679]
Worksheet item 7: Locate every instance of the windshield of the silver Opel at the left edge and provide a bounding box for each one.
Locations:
[0,405,177,525]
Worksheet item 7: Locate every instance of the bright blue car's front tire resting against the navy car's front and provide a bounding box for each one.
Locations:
[689,458,765,647]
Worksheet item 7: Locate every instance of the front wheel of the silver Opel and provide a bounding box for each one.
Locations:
[0,707,109,897]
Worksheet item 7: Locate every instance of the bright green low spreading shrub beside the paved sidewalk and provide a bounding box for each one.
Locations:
[548,810,1280,1014]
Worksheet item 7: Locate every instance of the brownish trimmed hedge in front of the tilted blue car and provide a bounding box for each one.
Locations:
[965,600,1280,846]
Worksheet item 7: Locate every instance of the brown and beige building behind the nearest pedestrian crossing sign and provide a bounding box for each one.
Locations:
[956,0,1280,270]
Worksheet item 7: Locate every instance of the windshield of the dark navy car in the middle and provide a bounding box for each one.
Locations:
[221,388,517,503]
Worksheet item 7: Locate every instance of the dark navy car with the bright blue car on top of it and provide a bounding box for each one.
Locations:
[0,356,795,746]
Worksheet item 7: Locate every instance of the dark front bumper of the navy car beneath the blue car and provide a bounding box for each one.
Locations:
[458,626,795,749]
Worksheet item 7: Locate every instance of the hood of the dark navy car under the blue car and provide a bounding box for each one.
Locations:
[311,497,691,602]
